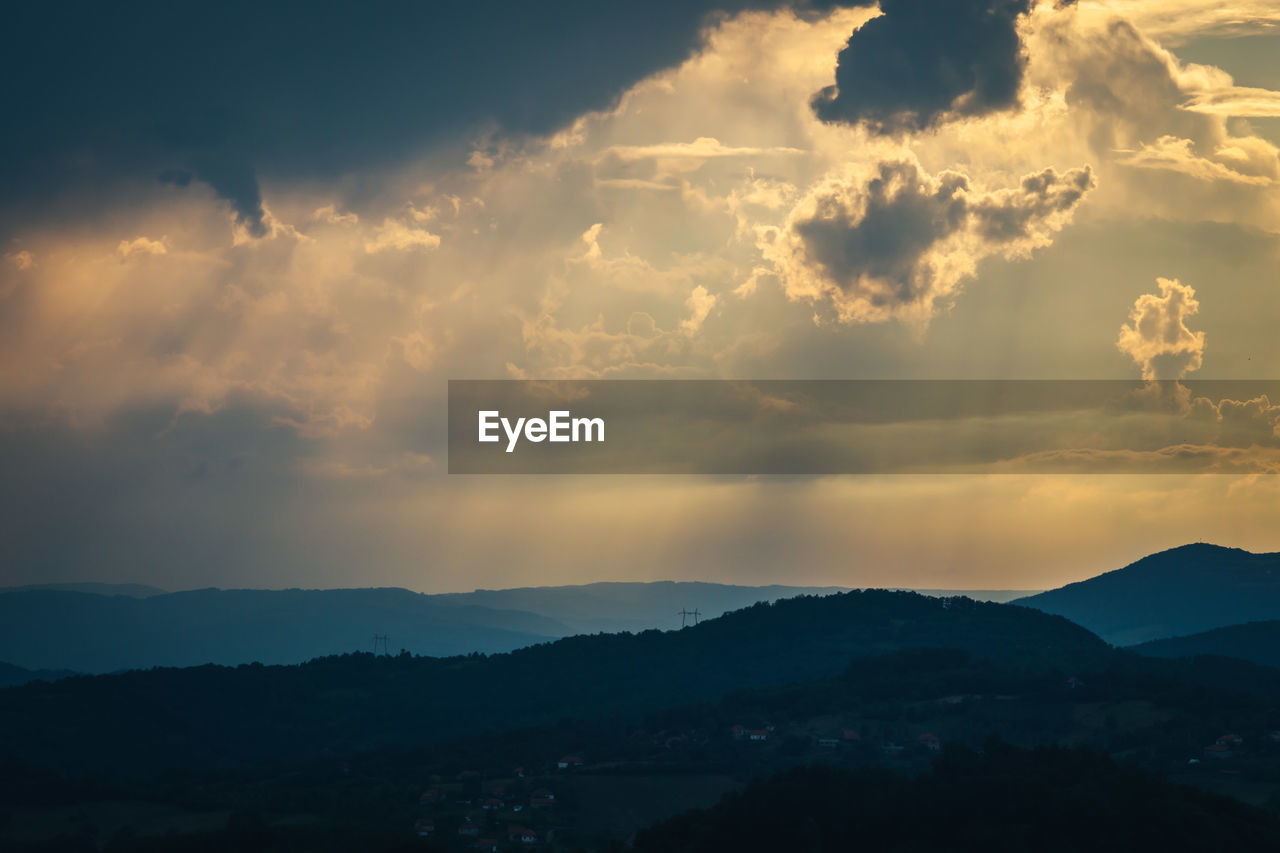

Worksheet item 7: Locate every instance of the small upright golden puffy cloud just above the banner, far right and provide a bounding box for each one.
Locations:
[1116,278,1204,379]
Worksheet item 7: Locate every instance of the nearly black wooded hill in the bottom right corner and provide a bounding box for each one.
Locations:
[635,742,1280,853]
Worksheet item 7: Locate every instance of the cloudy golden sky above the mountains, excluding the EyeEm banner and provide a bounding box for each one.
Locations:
[0,0,1280,592]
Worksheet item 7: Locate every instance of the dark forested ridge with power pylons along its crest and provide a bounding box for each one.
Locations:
[0,590,1110,775]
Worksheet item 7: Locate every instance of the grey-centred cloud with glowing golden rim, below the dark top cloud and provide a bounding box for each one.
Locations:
[760,159,1093,323]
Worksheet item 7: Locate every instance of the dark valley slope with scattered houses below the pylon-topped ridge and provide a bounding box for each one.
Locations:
[12,649,1280,853]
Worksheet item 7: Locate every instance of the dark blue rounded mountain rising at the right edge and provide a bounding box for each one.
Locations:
[1015,544,1280,646]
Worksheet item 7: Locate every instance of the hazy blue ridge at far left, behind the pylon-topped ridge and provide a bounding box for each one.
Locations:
[0,589,570,672]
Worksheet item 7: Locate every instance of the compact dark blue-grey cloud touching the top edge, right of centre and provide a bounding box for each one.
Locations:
[813,0,1030,133]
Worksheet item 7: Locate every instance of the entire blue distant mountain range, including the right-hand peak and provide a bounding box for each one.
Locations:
[20,544,1280,672]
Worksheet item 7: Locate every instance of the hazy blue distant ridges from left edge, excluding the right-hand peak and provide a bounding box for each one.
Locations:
[0,581,1039,672]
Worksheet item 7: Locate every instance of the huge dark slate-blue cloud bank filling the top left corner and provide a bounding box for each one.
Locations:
[0,0,834,233]
